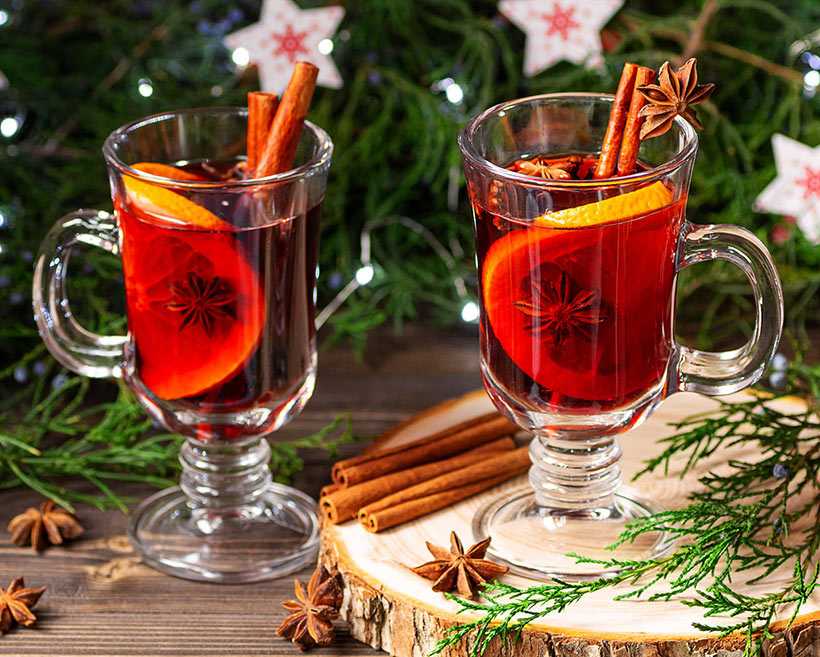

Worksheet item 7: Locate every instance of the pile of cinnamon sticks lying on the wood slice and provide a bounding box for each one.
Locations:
[319,413,530,532]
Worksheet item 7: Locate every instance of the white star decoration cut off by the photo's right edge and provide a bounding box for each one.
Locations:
[754,134,820,244]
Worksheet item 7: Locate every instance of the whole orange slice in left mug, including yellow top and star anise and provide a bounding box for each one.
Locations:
[116,163,267,399]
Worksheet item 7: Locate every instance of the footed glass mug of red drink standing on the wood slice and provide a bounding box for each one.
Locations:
[459,94,783,578]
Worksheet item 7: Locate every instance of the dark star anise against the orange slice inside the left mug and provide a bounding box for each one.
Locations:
[165,271,236,337]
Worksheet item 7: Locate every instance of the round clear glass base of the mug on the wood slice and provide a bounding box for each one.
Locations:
[473,486,674,581]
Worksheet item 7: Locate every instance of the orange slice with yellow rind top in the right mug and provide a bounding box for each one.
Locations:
[481,183,683,399]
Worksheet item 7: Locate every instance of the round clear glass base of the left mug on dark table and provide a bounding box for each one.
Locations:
[128,484,319,584]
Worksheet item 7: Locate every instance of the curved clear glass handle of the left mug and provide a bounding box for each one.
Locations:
[32,210,128,378]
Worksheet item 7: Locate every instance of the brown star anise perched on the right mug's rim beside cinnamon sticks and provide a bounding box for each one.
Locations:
[638,57,715,139]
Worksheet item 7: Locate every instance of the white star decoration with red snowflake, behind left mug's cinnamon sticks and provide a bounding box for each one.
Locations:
[225,0,344,93]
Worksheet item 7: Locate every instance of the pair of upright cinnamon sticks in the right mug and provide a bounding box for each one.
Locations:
[595,62,656,178]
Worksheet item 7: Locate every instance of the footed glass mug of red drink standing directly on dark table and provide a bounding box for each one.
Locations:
[33,108,333,582]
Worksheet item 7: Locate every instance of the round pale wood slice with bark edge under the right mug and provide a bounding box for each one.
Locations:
[321,390,820,657]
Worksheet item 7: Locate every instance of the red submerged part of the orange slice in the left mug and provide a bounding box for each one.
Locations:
[118,197,267,399]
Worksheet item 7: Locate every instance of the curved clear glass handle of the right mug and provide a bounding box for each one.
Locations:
[671,223,783,395]
